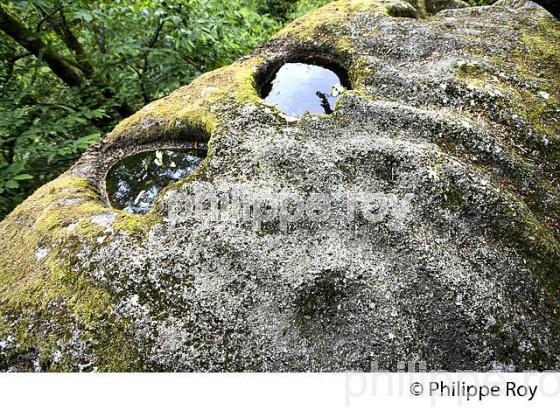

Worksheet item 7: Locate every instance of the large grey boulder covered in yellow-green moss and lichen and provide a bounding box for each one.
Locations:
[0,0,560,371]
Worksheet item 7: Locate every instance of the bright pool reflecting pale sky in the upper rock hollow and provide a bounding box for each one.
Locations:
[261,63,348,116]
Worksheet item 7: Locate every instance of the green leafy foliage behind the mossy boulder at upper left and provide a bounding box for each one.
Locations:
[0,0,281,218]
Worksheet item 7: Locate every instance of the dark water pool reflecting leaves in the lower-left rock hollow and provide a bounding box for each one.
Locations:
[106,150,205,214]
